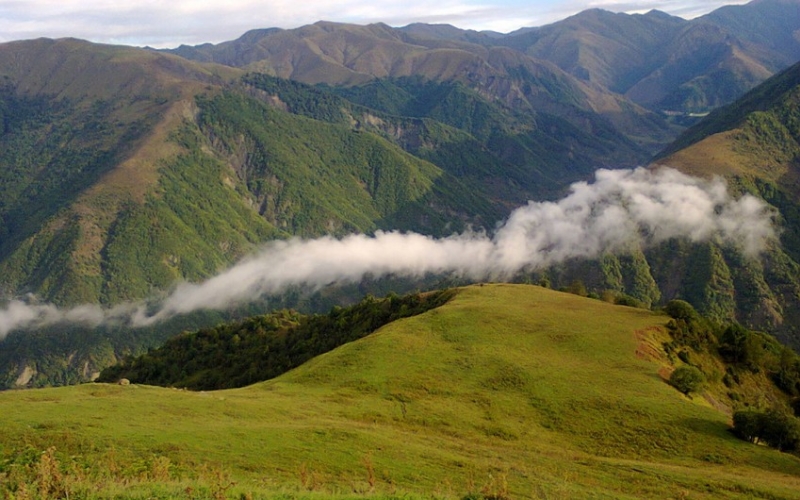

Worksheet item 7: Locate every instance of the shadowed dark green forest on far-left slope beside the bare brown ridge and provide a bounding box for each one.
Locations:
[0,91,147,261]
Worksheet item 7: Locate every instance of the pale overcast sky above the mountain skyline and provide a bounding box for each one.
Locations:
[0,0,747,48]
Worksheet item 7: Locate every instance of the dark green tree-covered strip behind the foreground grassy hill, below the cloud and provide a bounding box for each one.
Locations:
[98,290,454,390]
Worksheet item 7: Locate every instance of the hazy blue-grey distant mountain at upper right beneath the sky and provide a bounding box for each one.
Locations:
[500,0,800,113]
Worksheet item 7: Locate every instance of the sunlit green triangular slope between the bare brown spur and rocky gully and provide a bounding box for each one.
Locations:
[101,130,283,304]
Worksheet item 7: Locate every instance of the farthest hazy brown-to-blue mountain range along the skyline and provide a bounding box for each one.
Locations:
[172,0,800,115]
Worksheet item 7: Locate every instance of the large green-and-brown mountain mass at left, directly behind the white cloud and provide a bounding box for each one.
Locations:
[0,39,666,386]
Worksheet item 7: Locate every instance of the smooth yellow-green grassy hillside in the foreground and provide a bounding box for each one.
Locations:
[0,285,800,498]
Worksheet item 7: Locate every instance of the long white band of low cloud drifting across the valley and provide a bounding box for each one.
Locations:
[0,168,776,339]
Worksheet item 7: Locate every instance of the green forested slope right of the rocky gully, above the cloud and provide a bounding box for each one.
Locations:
[198,88,441,236]
